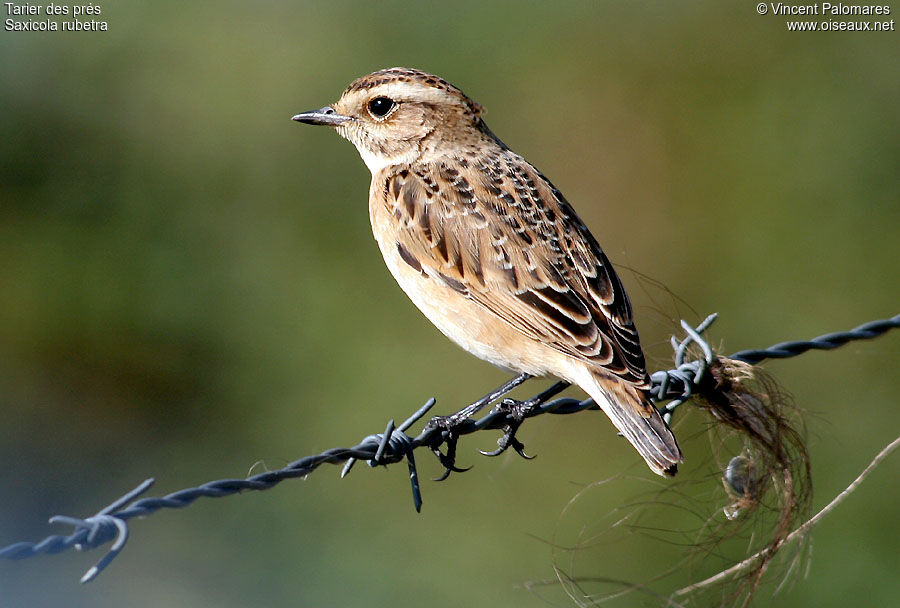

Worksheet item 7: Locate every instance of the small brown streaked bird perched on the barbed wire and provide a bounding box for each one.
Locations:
[292,67,684,476]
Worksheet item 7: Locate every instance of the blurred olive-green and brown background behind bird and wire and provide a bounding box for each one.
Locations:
[0,0,900,607]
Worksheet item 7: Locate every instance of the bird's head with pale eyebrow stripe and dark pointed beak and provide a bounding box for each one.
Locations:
[293,68,487,174]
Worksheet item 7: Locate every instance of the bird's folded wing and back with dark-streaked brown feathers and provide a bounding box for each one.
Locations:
[381,150,649,389]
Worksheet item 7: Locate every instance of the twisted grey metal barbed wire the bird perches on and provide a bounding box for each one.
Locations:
[0,314,900,583]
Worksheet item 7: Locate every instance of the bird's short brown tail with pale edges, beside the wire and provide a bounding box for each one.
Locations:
[578,370,684,477]
